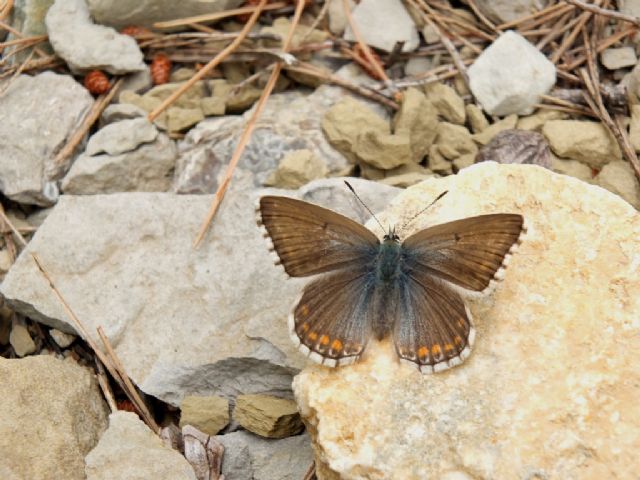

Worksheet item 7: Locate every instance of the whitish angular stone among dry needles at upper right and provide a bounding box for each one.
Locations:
[469,30,556,116]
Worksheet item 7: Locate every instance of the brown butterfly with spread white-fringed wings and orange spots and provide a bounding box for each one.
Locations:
[257,196,524,373]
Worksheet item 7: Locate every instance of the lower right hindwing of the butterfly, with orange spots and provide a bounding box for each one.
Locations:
[393,272,475,373]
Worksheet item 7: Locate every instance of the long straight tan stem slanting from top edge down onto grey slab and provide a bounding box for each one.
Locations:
[193,0,305,248]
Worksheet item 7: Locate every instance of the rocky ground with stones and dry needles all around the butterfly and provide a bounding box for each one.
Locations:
[0,0,640,480]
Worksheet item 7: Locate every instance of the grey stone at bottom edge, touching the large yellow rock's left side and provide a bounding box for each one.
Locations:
[214,431,313,480]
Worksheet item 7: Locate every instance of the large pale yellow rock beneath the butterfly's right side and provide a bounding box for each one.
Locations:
[294,162,640,480]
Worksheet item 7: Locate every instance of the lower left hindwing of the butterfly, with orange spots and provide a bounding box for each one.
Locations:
[289,267,375,366]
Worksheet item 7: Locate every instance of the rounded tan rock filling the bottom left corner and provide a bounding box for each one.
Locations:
[0,355,108,480]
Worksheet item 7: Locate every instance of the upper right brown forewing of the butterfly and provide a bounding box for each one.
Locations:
[402,213,524,291]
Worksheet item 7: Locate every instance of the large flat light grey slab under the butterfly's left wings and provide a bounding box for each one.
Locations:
[0,176,398,406]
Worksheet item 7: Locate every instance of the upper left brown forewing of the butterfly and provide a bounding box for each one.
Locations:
[260,196,380,277]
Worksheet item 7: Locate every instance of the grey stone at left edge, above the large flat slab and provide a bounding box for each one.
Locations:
[0,72,93,206]
